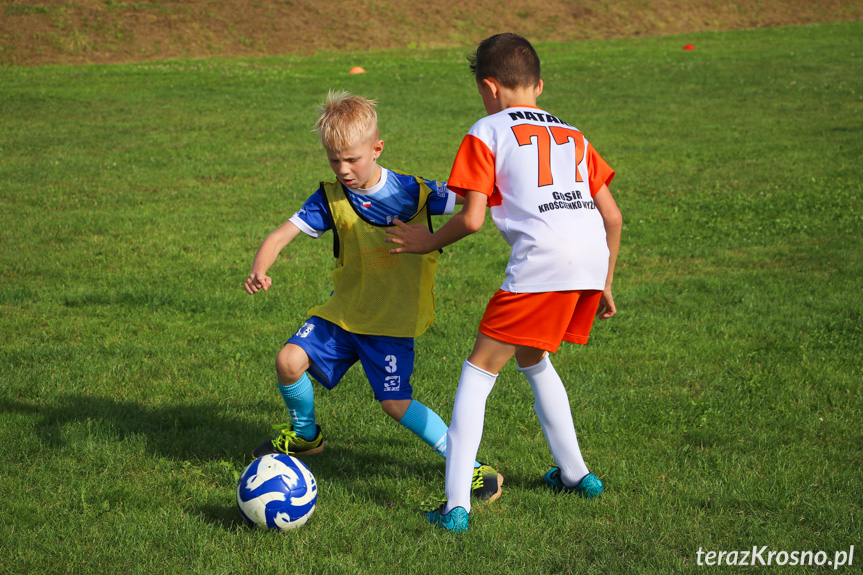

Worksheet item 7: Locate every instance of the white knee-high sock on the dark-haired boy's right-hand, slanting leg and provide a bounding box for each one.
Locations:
[518,355,589,486]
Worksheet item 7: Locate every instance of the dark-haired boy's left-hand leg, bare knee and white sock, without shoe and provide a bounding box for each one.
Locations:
[444,333,515,513]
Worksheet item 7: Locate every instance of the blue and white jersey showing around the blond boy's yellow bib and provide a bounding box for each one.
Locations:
[290,168,455,238]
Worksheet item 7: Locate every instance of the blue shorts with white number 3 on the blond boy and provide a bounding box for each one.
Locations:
[287,316,414,401]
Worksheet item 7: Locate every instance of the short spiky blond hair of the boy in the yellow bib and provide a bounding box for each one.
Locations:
[315,90,380,152]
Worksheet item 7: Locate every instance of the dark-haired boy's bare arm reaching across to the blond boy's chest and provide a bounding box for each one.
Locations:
[386,191,488,254]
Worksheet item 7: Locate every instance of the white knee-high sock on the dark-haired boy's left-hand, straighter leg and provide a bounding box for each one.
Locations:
[444,361,497,513]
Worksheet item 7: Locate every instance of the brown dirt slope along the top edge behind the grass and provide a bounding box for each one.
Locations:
[0,0,863,65]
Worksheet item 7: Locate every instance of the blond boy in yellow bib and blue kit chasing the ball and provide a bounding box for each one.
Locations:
[244,92,503,500]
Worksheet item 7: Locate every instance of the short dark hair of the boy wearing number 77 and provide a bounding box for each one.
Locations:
[467,32,540,89]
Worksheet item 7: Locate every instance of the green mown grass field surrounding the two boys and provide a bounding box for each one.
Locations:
[0,22,863,574]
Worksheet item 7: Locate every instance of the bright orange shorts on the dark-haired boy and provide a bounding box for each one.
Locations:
[479,290,602,353]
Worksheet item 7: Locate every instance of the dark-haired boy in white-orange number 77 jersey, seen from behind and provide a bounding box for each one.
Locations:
[387,34,622,531]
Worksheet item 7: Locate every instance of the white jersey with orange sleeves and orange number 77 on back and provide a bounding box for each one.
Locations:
[447,106,614,293]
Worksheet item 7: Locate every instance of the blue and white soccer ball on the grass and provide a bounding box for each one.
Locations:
[237,453,318,531]
